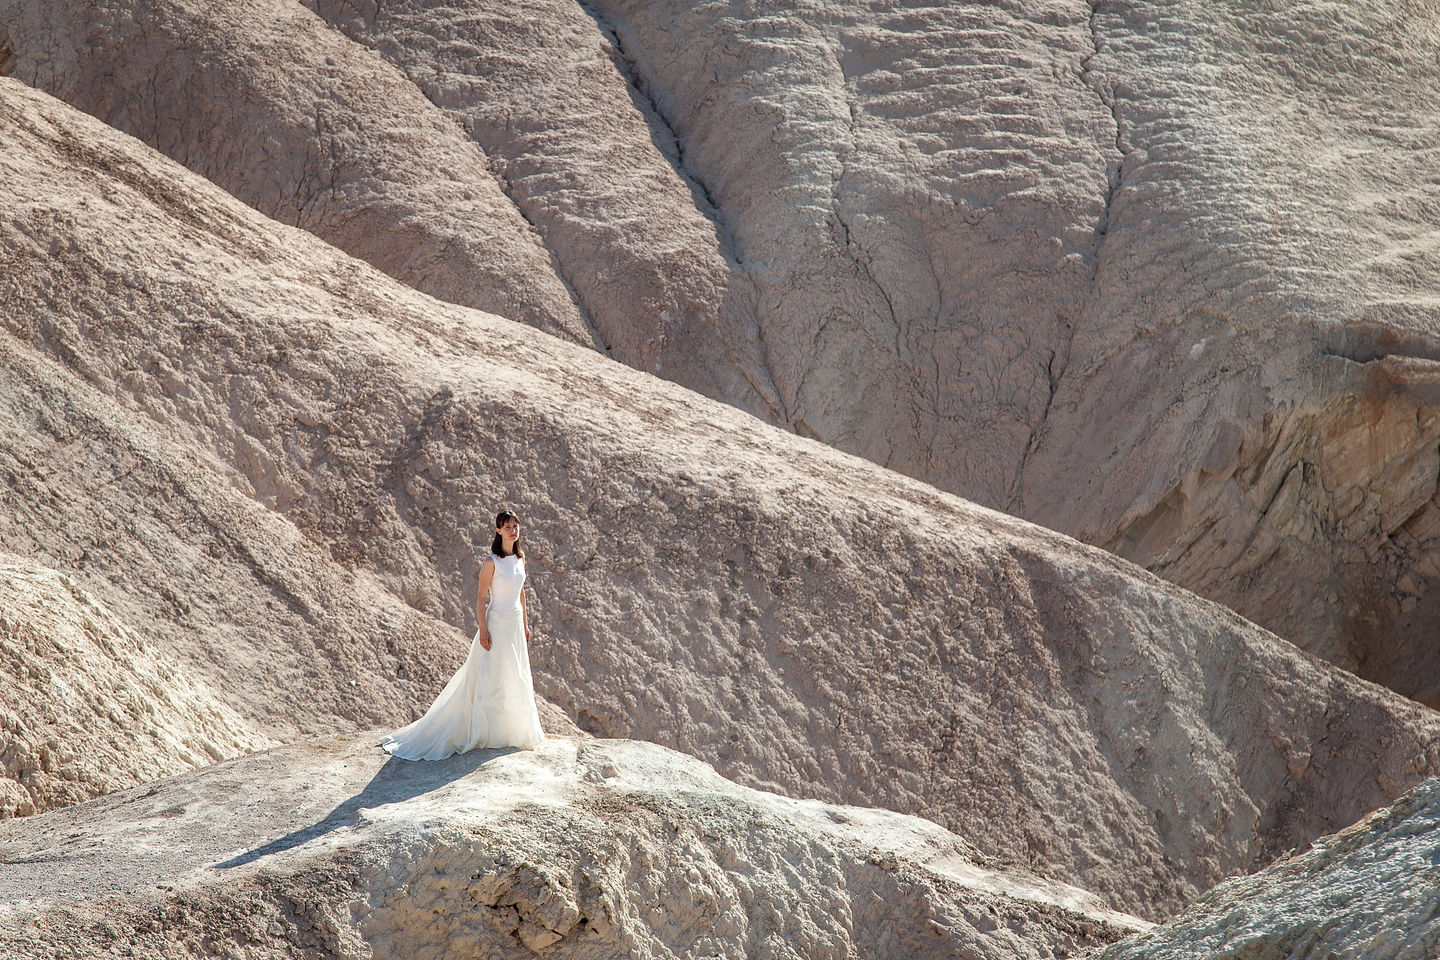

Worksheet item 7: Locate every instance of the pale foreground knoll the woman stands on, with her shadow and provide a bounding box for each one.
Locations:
[0,737,1148,960]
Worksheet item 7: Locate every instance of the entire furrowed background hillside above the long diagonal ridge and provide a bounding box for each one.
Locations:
[0,0,1440,705]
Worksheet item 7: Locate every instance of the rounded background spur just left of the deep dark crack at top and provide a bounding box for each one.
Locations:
[305,0,737,394]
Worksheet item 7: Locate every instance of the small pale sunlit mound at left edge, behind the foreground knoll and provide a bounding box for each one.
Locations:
[0,553,272,819]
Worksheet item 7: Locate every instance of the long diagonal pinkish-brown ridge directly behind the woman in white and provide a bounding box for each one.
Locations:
[0,81,1440,917]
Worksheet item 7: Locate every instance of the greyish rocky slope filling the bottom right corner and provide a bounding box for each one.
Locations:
[1096,780,1440,960]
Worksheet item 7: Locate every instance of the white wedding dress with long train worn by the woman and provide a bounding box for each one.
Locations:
[380,554,544,760]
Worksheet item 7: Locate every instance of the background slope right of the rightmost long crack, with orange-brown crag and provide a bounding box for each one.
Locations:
[1022,1,1440,699]
